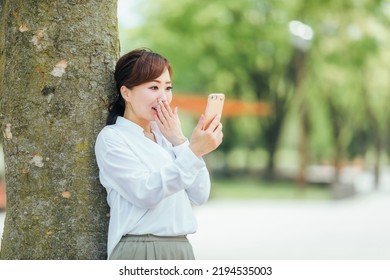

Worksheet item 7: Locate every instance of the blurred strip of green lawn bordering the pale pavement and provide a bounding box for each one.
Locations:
[210,178,331,200]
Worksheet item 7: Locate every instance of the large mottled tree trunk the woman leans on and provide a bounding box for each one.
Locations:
[0,0,119,259]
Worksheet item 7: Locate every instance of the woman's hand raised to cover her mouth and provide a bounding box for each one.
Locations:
[155,101,187,146]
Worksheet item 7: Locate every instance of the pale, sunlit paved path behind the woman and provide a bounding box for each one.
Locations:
[0,192,390,260]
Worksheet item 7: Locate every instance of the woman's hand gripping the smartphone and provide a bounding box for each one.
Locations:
[189,115,223,157]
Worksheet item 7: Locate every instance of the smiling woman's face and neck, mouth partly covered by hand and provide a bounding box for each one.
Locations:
[122,69,172,129]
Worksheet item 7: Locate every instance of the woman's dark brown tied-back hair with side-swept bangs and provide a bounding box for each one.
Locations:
[106,49,172,125]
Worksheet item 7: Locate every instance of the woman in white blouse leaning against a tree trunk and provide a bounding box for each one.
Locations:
[95,49,223,259]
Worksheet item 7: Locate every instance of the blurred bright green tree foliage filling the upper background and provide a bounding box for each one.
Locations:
[122,0,390,175]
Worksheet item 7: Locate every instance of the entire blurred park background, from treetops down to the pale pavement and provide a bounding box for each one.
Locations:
[0,0,390,259]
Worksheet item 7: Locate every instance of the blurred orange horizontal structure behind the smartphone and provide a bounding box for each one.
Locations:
[171,93,272,117]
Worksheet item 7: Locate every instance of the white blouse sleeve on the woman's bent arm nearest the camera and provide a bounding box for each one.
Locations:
[95,130,205,208]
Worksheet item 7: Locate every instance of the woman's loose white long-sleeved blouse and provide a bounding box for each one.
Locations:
[95,117,210,258]
